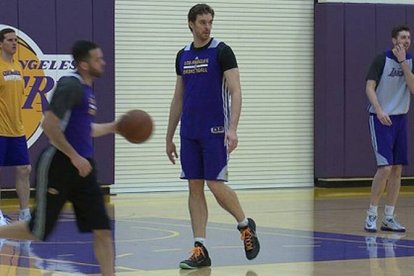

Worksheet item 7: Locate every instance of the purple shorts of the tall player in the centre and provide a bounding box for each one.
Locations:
[180,135,228,181]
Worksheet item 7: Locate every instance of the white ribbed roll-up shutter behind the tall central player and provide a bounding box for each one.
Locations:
[112,0,314,192]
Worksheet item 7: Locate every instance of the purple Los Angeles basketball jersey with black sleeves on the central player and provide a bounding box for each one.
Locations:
[176,39,237,139]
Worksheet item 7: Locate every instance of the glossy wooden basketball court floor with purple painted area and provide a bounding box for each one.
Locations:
[0,188,414,276]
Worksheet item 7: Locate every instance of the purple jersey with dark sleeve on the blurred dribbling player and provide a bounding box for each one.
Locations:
[49,74,97,158]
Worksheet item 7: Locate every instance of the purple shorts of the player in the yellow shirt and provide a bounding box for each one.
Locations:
[0,136,30,167]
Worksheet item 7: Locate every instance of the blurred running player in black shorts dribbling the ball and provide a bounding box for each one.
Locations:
[0,40,116,276]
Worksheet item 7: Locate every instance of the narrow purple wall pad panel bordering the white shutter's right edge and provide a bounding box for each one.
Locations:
[314,4,345,177]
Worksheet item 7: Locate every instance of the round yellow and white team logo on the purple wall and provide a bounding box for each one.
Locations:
[0,24,74,148]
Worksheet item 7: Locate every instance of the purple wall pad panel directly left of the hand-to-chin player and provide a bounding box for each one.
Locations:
[343,4,376,176]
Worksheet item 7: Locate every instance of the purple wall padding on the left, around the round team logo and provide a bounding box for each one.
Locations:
[0,0,115,188]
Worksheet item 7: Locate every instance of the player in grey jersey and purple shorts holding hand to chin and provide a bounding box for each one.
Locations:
[364,26,414,232]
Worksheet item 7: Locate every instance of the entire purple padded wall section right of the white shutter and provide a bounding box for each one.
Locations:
[315,3,414,178]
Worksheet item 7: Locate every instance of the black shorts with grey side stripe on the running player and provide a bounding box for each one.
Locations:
[29,147,110,240]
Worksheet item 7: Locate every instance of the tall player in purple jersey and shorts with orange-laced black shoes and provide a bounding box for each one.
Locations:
[166,4,260,269]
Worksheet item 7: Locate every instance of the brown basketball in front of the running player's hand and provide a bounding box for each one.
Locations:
[116,109,153,144]
